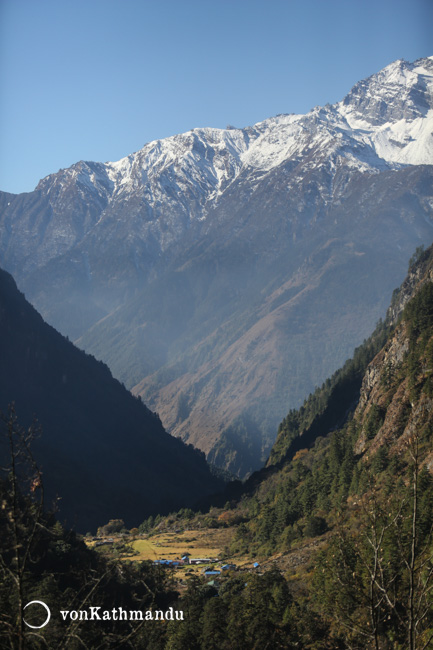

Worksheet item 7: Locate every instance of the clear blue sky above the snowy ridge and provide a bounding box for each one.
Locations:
[0,0,433,192]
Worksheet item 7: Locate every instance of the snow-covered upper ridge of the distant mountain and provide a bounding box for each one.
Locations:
[38,57,433,220]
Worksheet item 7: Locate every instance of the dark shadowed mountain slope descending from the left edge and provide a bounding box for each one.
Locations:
[0,270,221,531]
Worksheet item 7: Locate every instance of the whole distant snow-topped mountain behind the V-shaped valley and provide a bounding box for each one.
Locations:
[0,58,433,475]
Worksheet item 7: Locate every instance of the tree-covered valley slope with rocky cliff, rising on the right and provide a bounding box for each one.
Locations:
[179,247,433,650]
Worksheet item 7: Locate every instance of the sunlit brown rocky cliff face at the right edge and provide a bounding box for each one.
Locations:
[354,249,433,460]
